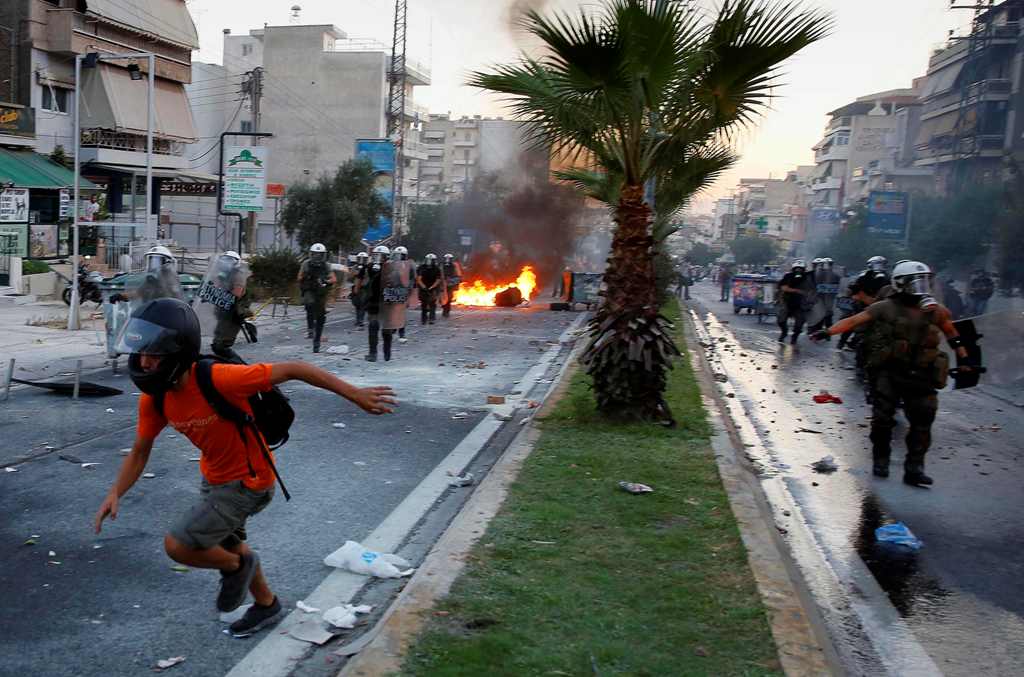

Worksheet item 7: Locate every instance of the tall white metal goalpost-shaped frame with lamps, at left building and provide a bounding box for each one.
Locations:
[68,52,157,331]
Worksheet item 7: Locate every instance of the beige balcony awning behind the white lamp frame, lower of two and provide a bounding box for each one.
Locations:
[82,64,198,143]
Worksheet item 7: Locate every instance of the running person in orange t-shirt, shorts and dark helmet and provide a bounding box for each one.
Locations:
[95,299,395,637]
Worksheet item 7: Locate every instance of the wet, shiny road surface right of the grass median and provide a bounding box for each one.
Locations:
[690,276,1024,675]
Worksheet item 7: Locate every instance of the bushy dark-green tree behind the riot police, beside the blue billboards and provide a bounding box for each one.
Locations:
[281,159,391,252]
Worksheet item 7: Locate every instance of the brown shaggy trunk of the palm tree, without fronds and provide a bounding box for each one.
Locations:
[583,185,679,422]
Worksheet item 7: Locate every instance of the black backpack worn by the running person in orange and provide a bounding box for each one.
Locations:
[154,356,295,501]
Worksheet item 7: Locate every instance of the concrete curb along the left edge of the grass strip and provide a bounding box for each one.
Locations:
[338,333,586,677]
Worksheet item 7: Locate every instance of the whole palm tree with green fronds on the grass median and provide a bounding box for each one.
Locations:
[470,0,830,422]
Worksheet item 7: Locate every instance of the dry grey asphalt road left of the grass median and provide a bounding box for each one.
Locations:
[0,304,578,677]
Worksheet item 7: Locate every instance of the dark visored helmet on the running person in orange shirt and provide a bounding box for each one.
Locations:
[116,298,202,395]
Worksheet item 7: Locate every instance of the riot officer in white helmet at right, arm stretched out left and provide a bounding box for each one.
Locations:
[812,261,970,486]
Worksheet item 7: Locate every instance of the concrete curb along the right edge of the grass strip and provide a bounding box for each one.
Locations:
[682,308,846,676]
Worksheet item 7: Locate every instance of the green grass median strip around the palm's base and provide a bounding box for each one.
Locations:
[403,306,781,676]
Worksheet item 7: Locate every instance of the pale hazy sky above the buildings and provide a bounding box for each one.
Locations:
[188,0,970,211]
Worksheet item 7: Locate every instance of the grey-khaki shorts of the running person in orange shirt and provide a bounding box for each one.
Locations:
[171,479,274,550]
